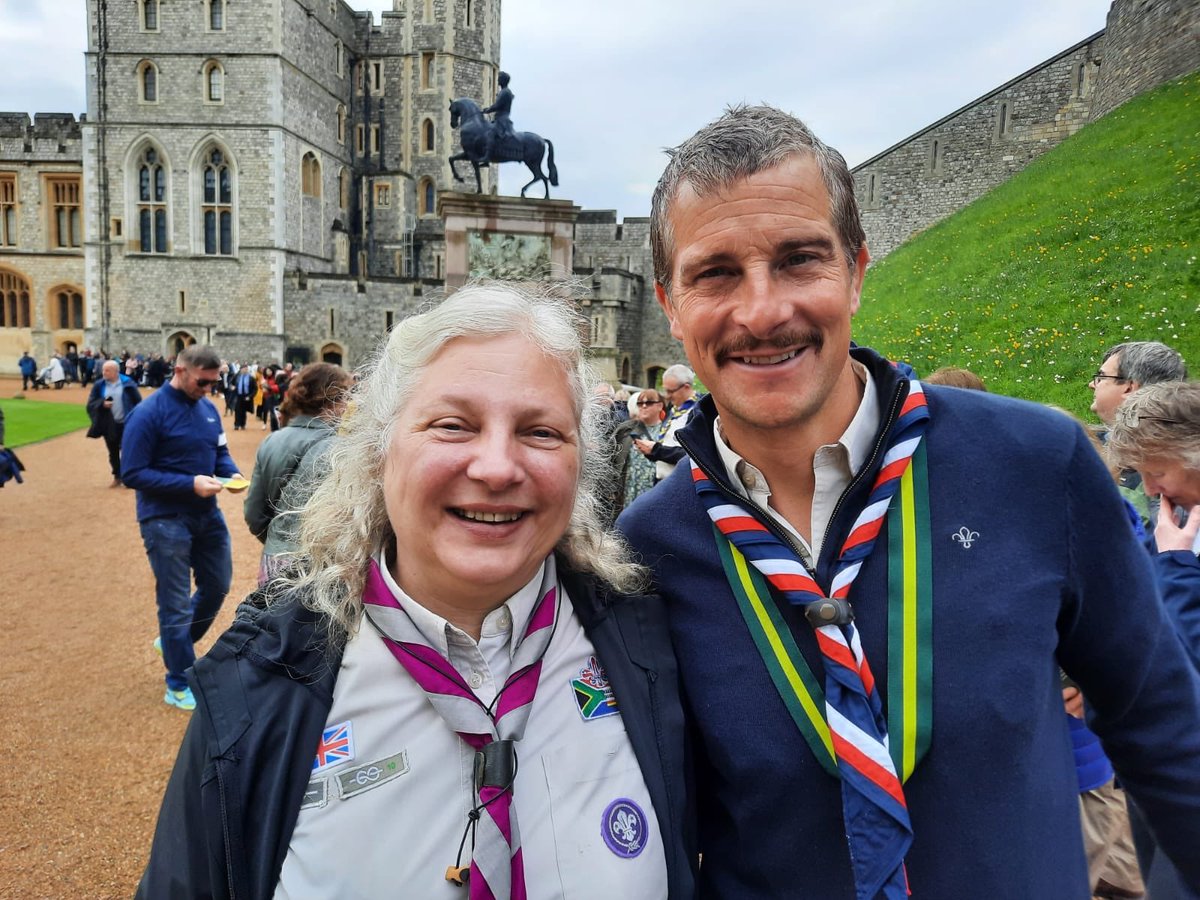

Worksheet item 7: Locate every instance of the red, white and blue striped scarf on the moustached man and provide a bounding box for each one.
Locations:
[691,379,929,900]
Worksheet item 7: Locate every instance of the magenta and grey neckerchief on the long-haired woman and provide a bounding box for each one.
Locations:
[362,557,562,900]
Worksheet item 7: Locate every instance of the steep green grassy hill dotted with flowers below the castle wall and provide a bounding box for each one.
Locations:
[854,72,1200,415]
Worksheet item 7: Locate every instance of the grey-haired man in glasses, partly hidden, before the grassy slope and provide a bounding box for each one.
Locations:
[1087,341,1188,520]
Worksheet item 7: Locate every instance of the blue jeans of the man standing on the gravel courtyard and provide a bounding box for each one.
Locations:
[140,509,233,691]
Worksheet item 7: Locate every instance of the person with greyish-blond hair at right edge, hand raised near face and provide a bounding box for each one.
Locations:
[1106,382,1200,900]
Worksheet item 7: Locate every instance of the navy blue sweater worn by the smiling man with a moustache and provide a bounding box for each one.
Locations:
[619,348,1200,900]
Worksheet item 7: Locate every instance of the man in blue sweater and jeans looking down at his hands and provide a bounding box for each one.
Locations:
[121,344,241,710]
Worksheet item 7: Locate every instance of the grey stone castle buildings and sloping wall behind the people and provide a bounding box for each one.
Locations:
[0,0,1200,384]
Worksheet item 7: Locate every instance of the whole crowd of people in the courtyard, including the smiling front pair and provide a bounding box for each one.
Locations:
[23,107,1200,900]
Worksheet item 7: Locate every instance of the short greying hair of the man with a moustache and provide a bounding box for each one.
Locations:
[650,104,866,294]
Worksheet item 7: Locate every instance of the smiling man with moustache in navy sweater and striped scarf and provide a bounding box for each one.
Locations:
[620,107,1200,900]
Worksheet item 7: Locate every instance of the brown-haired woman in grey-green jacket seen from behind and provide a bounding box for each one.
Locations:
[242,362,350,584]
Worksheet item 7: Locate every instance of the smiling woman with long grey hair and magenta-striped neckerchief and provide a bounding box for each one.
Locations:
[139,284,696,900]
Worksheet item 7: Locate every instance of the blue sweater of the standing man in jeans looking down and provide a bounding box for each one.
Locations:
[121,384,238,522]
